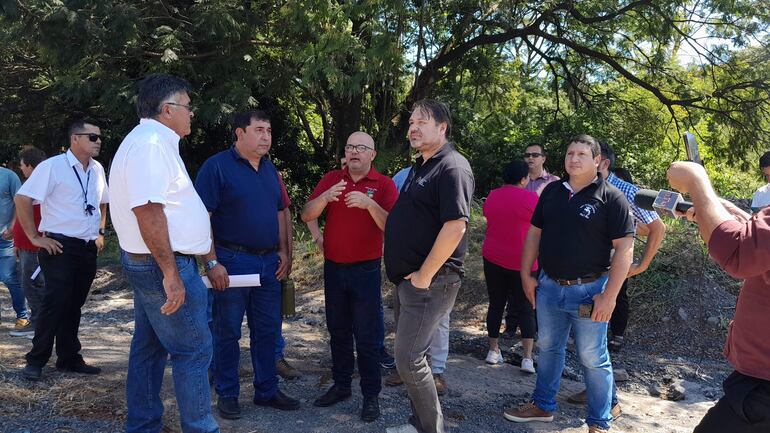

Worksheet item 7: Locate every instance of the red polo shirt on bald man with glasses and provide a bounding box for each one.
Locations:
[308,167,398,263]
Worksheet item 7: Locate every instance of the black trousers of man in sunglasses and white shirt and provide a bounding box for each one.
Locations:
[26,237,96,367]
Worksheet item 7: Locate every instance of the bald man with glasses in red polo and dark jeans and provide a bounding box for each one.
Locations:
[302,132,398,422]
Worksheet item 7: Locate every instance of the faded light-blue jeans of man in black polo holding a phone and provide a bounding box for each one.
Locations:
[532,272,613,429]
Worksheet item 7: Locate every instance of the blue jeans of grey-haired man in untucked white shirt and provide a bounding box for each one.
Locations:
[121,251,219,433]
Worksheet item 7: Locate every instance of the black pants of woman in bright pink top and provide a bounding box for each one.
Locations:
[484,259,536,338]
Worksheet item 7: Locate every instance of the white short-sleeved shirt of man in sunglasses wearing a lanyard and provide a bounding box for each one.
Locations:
[17,150,109,241]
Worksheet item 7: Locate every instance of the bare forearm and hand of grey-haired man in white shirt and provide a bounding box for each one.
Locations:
[132,203,185,315]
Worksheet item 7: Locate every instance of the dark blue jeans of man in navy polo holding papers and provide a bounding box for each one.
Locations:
[214,246,281,400]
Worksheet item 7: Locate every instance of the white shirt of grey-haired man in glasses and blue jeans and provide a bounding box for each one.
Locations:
[110,119,211,255]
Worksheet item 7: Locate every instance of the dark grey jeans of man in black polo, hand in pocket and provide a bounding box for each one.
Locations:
[394,269,461,433]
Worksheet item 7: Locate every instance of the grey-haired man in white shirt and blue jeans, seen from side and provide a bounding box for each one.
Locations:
[110,74,219,433]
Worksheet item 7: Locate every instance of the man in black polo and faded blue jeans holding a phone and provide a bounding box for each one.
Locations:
[504,135,634,433]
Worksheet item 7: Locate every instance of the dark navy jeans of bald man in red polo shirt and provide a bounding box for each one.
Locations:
[324,259,385,397]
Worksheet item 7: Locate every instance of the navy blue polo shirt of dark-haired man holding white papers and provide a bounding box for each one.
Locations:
[195,146,283,249]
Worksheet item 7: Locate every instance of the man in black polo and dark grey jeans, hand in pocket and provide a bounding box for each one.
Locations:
[384,100,474,433]
